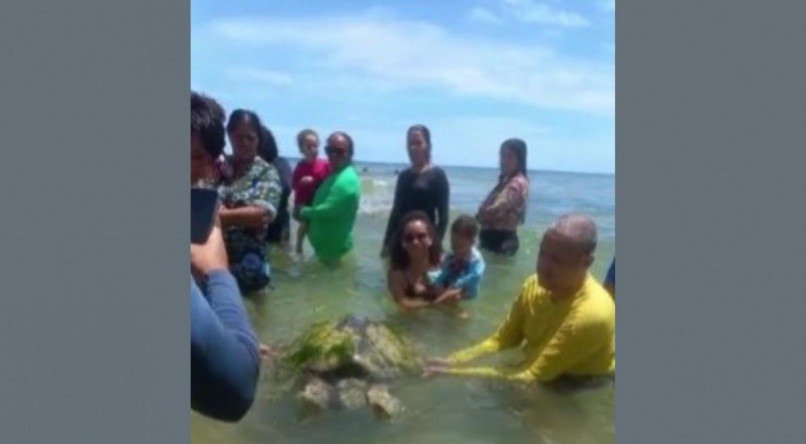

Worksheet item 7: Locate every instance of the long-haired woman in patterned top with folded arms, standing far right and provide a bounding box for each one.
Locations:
[476,138,529,256]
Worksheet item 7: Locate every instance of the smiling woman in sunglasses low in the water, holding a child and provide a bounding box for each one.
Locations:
[386,211,442,310]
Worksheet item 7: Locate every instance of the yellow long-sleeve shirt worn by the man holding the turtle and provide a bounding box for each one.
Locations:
[448,274,616,382]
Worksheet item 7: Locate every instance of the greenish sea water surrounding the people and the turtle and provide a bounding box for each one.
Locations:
[191,162,615,444]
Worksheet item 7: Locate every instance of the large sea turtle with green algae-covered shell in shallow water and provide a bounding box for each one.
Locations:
[282,315,421,418]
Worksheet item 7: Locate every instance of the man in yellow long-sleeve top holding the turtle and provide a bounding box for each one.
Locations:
[426,214,616,382]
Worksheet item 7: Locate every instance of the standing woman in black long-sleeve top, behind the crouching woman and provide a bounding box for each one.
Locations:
[381,125,450,257]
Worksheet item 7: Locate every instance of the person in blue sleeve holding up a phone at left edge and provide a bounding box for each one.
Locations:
[190,92,261,421]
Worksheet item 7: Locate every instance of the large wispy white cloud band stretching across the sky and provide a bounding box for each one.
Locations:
[209,15,615,117]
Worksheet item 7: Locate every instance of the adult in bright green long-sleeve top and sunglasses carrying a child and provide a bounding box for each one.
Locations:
[300,131,361,263]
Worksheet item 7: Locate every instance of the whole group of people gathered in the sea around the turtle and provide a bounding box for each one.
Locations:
[191,92,615,420]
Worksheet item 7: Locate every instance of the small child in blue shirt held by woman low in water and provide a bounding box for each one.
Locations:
[432,215,484,303]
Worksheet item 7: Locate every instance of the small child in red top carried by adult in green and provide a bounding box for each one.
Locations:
[291,129,330,255]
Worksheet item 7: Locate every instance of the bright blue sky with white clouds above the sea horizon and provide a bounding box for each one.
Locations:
[191,0,615,173]
